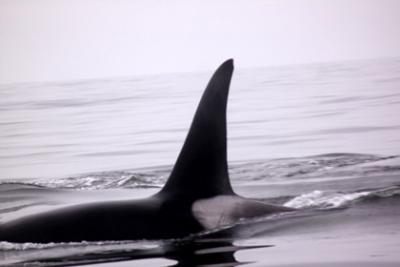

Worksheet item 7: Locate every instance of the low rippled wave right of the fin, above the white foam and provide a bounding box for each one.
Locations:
[230,153,400,182]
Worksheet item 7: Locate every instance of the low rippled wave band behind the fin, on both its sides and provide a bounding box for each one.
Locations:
[0,153,400,190]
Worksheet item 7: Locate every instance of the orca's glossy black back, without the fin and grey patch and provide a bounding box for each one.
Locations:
[0,194,203,243]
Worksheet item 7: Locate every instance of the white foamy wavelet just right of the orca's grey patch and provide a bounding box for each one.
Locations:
[284,186,400,209]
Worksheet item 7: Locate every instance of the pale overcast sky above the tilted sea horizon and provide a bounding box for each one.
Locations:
[0,0,400,83]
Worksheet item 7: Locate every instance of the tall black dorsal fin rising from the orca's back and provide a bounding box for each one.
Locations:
[161,59,233,198]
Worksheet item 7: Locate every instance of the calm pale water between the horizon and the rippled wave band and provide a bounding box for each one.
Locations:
[0,60,400,179]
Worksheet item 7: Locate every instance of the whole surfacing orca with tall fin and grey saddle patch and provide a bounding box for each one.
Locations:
[0,59,292,243]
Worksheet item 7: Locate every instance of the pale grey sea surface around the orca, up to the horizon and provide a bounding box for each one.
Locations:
[0,58,400,267]
